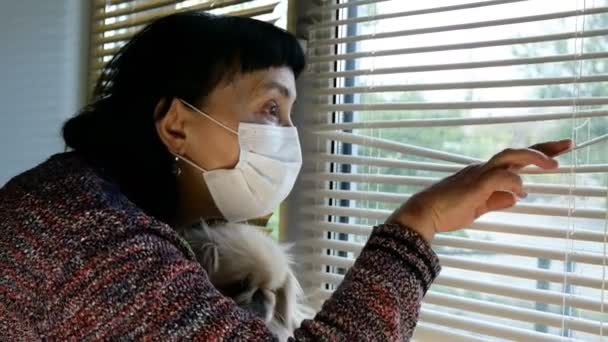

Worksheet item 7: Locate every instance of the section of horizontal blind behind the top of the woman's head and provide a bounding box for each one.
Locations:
[89,0,287,92]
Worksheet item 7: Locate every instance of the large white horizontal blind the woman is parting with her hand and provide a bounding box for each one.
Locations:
[297,0,608,341]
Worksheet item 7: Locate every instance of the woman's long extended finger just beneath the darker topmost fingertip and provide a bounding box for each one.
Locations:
[483,148,558,172]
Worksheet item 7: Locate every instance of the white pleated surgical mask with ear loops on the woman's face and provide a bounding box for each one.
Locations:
[176,101,302,222]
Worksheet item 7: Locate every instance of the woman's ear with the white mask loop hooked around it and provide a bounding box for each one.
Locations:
[154,98,188,155]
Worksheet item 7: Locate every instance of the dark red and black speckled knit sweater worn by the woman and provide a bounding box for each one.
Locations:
[0,153,440,341]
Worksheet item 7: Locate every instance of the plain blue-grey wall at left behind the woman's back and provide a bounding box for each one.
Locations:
[0,0,90,186]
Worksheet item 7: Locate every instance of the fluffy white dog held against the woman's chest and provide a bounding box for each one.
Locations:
[175,222,314,341]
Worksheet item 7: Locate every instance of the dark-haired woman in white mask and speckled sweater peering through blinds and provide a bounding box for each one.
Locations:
[0,13,571,341]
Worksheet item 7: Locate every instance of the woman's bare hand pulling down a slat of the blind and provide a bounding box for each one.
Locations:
[387,139,572,242]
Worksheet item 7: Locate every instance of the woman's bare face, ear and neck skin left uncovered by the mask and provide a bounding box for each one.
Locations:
[156,67,296,223]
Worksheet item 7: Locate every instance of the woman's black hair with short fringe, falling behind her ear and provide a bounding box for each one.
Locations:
[63,12,305,222]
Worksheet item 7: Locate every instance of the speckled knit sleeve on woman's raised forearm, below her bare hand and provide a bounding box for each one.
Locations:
[295,224,440,341]
